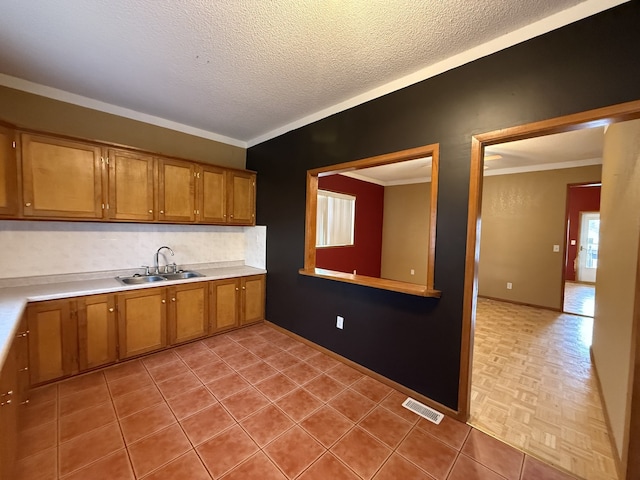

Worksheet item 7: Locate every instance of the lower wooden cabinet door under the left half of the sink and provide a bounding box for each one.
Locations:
[117,288,167,359]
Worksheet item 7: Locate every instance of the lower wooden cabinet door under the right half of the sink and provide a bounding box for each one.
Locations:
[169,282,209,345]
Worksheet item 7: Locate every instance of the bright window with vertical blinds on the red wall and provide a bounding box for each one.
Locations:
[316,190,356,247]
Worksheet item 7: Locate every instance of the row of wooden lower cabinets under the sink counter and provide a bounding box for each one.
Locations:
[20,275,265,386]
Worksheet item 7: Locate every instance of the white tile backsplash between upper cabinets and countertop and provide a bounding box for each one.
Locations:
[0,220,266,278]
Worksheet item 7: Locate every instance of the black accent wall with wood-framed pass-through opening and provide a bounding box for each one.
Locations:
[247,1,640,410]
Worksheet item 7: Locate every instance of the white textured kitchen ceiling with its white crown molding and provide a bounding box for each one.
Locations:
[0,0,625,147]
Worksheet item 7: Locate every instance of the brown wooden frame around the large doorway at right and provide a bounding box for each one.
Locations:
[458,100,640,480]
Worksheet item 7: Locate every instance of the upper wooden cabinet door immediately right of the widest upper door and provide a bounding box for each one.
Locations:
[107,150,155,222]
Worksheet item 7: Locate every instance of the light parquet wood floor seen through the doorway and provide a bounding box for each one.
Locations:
[469,299,618,480]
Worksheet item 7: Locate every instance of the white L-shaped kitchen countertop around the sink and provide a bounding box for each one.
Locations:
[0,264,267,366]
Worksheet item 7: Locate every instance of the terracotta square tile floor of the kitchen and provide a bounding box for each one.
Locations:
[13,325,570,480]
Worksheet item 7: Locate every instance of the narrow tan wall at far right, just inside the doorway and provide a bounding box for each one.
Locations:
[592,120,640,457]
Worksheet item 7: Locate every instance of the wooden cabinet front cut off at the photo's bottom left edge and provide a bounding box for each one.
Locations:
[0,334,19,479]
